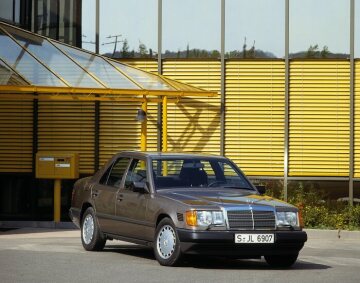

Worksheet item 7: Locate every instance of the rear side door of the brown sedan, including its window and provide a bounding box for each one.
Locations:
[92,157,130,233]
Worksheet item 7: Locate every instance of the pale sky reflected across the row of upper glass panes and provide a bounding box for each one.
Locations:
[82,0,360,58]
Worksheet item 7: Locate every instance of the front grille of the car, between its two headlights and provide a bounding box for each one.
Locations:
[227,210,275,230]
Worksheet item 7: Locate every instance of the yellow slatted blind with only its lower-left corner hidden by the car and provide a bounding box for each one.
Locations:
[225,60,285,176]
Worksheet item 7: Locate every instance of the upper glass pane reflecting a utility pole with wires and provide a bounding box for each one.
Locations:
[98,0,156,58]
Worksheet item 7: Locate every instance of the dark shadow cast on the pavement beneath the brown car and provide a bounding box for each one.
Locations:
[104,245,331,270]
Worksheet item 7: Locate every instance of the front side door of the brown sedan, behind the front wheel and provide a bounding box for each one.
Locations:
[116,159,153,241]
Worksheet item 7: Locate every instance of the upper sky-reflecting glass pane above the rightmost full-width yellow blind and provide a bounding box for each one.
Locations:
[290,0,350,59]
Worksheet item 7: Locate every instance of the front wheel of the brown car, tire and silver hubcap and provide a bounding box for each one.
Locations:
[154,218,182,266]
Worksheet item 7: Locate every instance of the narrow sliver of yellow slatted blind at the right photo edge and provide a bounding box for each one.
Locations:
[354,60,360,178]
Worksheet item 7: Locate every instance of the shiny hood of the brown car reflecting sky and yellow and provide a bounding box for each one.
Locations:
[158,189,292,208]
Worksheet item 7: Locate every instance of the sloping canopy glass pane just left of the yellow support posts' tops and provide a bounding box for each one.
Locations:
[54,42,139,89]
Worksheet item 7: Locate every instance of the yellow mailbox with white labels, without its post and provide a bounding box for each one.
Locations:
[36,152,79,179]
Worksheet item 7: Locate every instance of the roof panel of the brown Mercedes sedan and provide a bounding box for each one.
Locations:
[117,150,225,159]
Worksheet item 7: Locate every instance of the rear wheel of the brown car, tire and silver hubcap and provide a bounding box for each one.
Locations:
[81,207,106,251]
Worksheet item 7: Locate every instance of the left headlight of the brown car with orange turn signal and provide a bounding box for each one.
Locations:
[186,210,225,227]
